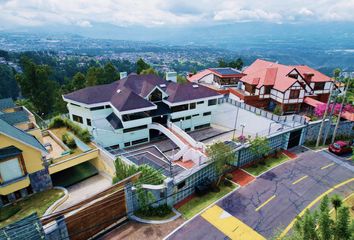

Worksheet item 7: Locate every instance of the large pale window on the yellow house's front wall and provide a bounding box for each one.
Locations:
[0,157,25,182]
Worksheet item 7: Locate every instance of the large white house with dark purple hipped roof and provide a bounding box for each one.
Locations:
[63,74,222,148]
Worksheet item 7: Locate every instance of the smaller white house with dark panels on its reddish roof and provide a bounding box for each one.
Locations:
[187,67,244,90]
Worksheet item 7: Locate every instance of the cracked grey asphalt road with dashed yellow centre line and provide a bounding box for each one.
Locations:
[168,151,354,240]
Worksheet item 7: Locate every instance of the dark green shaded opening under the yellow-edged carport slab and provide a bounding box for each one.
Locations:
[52,162,98,187]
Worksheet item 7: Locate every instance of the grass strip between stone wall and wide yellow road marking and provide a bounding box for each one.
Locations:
[177,184,236,219]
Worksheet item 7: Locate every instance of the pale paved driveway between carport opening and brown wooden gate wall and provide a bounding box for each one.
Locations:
[55,175,112,212]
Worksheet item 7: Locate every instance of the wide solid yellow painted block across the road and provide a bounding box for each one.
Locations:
[201,205,265,240]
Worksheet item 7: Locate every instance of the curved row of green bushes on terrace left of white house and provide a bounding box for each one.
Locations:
[49,116,91,143]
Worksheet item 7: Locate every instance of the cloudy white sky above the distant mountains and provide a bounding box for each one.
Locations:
[0,0,354,29]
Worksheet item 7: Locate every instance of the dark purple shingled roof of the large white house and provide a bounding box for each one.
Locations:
[64,74,220,111]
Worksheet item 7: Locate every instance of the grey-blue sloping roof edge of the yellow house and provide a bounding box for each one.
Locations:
[0,119,47,153]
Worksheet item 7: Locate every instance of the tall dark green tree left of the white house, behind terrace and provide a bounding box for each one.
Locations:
[16,57,56,115]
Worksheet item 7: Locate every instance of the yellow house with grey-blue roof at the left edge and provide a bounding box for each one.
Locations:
[0,99,52,206]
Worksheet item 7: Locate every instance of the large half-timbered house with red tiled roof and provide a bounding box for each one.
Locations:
[190,59,333,113]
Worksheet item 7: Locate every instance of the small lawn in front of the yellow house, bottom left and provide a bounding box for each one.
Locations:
[0,189,64,228]
